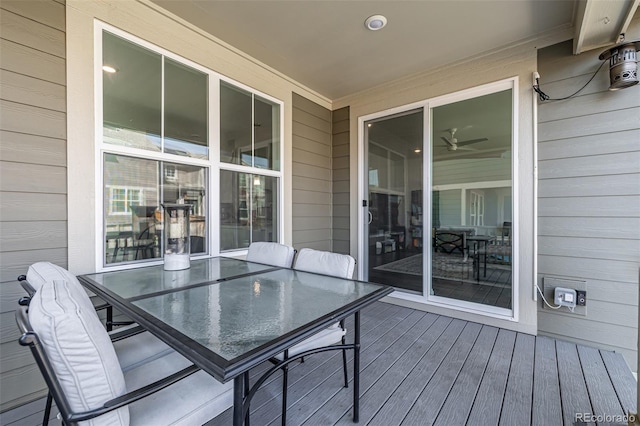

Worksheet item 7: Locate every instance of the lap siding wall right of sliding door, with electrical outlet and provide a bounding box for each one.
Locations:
[538,30,640,370]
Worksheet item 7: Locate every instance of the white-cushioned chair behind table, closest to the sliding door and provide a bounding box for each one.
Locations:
[276,248,356,425]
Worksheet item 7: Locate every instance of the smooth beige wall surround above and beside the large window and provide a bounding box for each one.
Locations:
[67,0,331,274]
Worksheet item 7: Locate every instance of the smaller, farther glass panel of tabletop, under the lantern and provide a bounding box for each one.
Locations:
[80,257,273,299]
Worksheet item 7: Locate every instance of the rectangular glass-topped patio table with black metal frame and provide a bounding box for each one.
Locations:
[78,257,392,426]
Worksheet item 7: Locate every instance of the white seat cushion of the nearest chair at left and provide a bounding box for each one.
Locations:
[124,352,233,426]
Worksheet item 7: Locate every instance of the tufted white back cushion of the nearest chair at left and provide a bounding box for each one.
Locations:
[29,280,129,426]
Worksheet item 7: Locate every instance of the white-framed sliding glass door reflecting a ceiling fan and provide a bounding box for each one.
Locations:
[361,80,518,316]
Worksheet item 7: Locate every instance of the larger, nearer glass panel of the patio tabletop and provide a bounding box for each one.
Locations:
[132,269,385,361]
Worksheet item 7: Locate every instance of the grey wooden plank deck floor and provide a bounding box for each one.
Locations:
[0,302,636,426]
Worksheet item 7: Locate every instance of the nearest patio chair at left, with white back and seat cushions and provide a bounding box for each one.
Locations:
[16,280,233,425]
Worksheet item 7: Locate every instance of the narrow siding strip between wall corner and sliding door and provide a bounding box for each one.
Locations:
[332,107,351,254]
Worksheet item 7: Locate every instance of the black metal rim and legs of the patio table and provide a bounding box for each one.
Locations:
[78,268,393,426]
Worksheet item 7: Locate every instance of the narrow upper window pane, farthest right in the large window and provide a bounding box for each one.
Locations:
[253,96,280,170]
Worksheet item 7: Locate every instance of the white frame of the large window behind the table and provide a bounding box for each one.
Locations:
[94,20,285,272]
